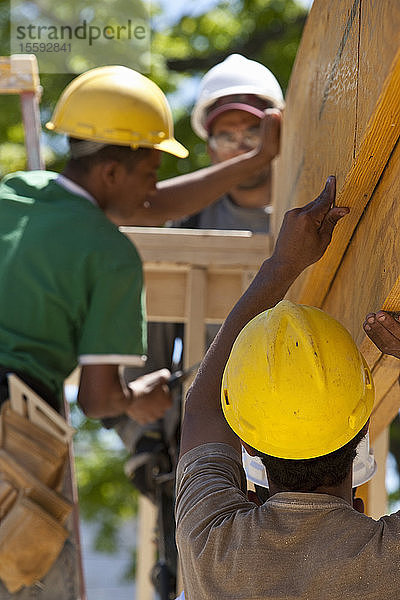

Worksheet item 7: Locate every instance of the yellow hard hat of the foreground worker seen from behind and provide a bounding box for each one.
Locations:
[221,300,374,459]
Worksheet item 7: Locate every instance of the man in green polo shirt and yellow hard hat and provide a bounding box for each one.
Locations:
[0,66,187,600]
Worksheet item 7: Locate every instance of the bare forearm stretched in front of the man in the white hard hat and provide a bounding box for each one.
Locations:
[135,109,281,226]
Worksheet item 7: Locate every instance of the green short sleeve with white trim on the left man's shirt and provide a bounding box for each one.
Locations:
[78,259,146,366]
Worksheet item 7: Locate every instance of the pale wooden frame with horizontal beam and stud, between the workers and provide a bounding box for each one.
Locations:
[121,227,272,600]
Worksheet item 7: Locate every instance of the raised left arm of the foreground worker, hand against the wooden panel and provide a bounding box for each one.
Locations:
[181,177,348,456]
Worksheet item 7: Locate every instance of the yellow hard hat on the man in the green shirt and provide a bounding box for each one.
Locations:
[46,65,188,158]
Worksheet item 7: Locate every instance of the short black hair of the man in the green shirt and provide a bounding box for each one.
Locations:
[68,138,151,173]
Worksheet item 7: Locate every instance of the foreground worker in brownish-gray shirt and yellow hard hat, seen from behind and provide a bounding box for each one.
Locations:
[176,178,400,600]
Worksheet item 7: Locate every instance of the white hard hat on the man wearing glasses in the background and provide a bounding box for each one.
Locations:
[191,54,284,140]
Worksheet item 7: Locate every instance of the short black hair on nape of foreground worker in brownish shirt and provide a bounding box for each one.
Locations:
[257,426,367,492]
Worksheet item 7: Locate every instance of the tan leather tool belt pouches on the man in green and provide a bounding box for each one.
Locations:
[0,374,73,593]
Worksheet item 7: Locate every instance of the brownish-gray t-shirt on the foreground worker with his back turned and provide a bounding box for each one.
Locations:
[176,444,400,600]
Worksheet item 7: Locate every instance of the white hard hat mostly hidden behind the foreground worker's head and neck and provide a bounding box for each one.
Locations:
[242,433,376,487]
